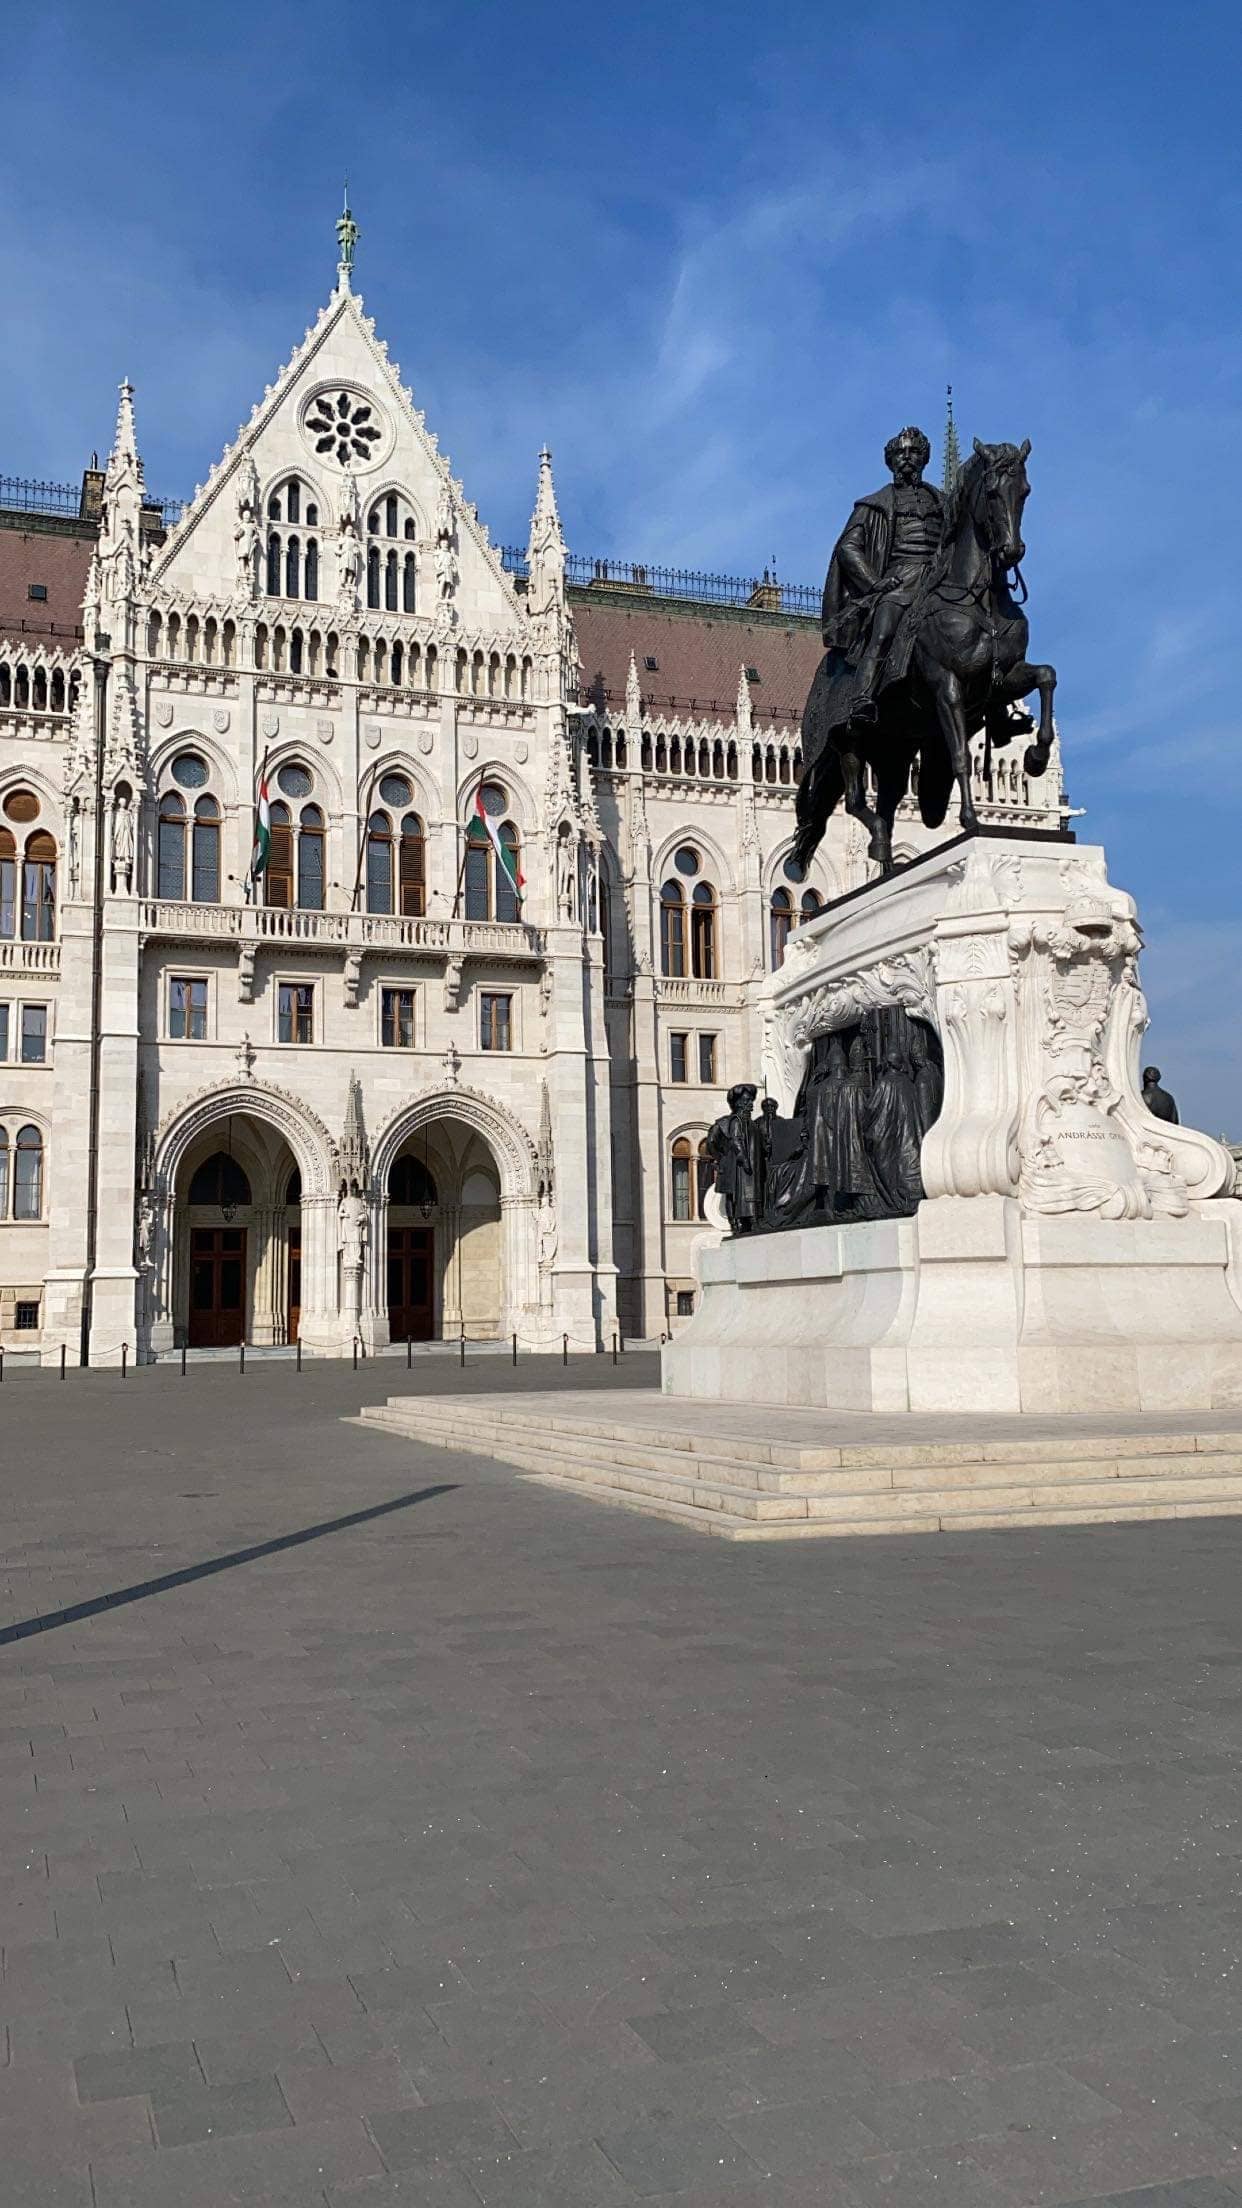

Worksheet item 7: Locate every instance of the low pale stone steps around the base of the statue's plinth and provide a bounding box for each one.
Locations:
[351,1393,1242,1541]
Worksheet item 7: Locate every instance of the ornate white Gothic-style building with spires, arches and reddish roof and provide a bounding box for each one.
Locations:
[0,216,1067,1365]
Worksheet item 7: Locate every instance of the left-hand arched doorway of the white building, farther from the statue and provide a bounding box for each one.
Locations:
[172,1113,303,1349]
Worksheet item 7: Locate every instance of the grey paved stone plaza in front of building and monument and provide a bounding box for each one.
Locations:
[0,1356,1242,2208]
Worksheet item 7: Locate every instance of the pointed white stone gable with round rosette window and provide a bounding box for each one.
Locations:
[150,285,524,631]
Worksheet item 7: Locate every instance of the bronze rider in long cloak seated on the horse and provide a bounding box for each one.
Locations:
[822,428,944,720]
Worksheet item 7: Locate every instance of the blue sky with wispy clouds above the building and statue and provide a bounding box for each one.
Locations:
[9,0,1242,1135]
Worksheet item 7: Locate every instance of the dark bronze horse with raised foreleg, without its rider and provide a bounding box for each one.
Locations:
[793,439,1056,874]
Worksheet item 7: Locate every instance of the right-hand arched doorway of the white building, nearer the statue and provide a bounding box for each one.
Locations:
[385,1117,508,1342]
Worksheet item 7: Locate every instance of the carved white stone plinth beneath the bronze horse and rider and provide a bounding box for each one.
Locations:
[663,837,1242,1413]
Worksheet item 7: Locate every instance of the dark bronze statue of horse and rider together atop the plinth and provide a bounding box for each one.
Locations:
[793,428,1056,874]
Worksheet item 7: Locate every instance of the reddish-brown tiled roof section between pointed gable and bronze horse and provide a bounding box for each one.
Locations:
[570,590,824,722]
